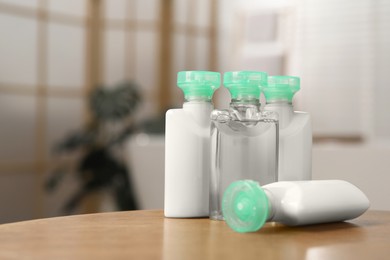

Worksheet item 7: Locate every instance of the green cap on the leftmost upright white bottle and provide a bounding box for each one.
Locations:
[177,71,221,100]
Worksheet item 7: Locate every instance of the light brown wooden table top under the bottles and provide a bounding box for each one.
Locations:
[0,211,390,260]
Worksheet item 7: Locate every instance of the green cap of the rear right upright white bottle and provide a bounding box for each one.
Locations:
[263,76,300,102]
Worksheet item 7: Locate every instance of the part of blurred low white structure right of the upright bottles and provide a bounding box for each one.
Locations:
[313,144,390,210]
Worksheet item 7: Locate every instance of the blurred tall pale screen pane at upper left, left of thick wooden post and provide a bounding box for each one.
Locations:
[48,23,86,88]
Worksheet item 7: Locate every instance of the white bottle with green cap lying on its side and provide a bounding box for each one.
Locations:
[222,180,370,232]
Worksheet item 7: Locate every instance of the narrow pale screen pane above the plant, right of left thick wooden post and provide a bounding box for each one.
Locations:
[103,30,126,87]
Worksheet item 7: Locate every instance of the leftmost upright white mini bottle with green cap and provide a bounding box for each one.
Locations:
[164,71,221,218]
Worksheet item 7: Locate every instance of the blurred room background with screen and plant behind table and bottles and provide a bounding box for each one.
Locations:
[0,0,390,223]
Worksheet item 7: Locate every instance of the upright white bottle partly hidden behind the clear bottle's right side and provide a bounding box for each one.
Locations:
[263,76,312,181]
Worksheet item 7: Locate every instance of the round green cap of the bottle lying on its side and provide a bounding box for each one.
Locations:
[222,180,269,233]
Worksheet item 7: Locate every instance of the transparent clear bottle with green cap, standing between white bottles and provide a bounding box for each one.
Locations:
[210,71,278,220]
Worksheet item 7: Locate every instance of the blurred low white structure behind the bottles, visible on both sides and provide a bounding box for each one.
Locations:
[127,134,390,210]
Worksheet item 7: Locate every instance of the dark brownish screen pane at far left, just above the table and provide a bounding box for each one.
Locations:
[0,172,36,224]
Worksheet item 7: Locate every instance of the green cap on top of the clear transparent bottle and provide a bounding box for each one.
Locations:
[223,71,268,99]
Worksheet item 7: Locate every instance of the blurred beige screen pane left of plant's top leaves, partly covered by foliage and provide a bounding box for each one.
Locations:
[46,97,84,159]
